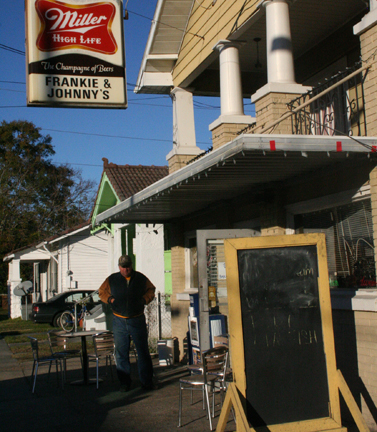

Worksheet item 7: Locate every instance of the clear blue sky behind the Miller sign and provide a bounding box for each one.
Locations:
[0,0,252,184]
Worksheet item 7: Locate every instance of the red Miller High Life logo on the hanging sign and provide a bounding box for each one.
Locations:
[35,0,118,54]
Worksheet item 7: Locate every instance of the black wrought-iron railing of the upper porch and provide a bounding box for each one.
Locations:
[287,65,367,136]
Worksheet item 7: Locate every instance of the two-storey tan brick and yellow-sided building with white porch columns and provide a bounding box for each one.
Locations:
[96,0,377,430]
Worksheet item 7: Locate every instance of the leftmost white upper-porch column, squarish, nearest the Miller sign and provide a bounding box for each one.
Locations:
[166,87,202,160]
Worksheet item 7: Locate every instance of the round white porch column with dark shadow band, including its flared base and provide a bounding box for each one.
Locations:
[251,0,311,102]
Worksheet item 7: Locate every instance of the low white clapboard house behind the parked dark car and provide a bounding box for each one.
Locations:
[4,222,108,319]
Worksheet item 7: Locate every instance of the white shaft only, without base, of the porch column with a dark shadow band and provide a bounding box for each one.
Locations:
[263,0,295,83]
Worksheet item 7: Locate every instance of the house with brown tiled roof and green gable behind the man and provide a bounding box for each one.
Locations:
[91,158,171,293]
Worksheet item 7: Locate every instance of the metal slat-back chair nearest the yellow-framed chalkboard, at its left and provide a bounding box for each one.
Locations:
[178,346,228,430]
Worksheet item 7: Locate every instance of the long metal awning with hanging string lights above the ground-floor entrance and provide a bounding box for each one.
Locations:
[96,135,377,224]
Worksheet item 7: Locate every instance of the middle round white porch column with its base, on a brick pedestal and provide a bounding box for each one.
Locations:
[209,40,255,130]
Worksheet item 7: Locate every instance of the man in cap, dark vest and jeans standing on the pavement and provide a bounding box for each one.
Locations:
[99,255,156,391]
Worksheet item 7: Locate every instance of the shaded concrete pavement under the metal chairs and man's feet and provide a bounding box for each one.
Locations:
[0,339,236,432]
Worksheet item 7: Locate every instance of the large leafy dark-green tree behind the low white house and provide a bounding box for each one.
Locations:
[0,120,94,291]
